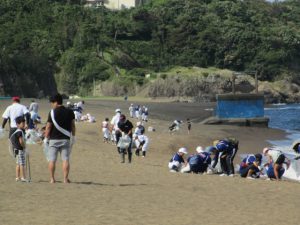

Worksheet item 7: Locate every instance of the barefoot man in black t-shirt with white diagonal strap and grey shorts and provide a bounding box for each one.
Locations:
[44,94,75,183]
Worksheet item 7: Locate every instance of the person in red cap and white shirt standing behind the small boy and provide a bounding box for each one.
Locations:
[2,96,30,137]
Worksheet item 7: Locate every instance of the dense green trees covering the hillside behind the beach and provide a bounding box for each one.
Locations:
[0,0,300,96]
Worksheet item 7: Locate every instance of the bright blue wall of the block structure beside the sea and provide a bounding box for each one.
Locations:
[216,94,264,119]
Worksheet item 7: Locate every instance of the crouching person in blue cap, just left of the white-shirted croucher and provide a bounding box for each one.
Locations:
[240,154,262,179]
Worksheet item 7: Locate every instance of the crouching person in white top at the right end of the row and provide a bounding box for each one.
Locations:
[263,148,290,181]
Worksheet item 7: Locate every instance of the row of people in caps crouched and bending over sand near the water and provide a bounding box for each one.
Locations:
[168,138,294,180]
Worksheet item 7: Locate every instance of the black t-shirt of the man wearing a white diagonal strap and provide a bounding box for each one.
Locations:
[47,106,75,140]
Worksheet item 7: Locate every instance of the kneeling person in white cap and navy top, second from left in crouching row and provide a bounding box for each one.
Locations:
[181,146,211,173]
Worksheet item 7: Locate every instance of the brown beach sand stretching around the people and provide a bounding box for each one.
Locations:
[0,100,300,225]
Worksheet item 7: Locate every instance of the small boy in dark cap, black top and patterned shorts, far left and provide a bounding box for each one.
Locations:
[10,116,27,182]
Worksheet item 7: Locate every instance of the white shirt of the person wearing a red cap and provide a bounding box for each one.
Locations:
[2,103,29,128]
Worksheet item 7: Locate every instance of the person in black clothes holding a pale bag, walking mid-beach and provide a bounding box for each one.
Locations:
[118,114,133,163]
